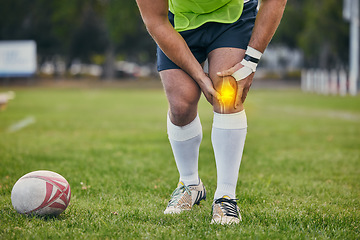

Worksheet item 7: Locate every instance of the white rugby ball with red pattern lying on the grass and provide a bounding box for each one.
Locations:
[11,170,71,216]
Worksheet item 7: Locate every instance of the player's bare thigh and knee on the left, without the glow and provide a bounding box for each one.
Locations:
[160,69,201,126]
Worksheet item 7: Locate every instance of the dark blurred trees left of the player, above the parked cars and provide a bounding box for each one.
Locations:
[0,0,155,77]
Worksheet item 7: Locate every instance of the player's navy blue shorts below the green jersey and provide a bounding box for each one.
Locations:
[157,0,258,72]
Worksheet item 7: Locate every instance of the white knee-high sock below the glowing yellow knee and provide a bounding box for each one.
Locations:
[211,110,247,199]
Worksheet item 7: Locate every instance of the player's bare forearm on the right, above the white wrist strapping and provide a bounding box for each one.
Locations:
[249,0,286,52]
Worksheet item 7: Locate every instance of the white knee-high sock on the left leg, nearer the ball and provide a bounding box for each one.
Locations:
[167,115,202,185]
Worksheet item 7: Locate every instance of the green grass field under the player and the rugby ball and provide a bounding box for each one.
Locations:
[0,82,360,239]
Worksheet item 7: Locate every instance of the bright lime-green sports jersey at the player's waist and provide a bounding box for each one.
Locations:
[169,0,244,32]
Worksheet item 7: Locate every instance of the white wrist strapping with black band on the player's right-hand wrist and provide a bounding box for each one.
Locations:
[231,46,262,81]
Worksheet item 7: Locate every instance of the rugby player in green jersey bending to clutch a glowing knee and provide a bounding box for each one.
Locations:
[137,0,286,224]
